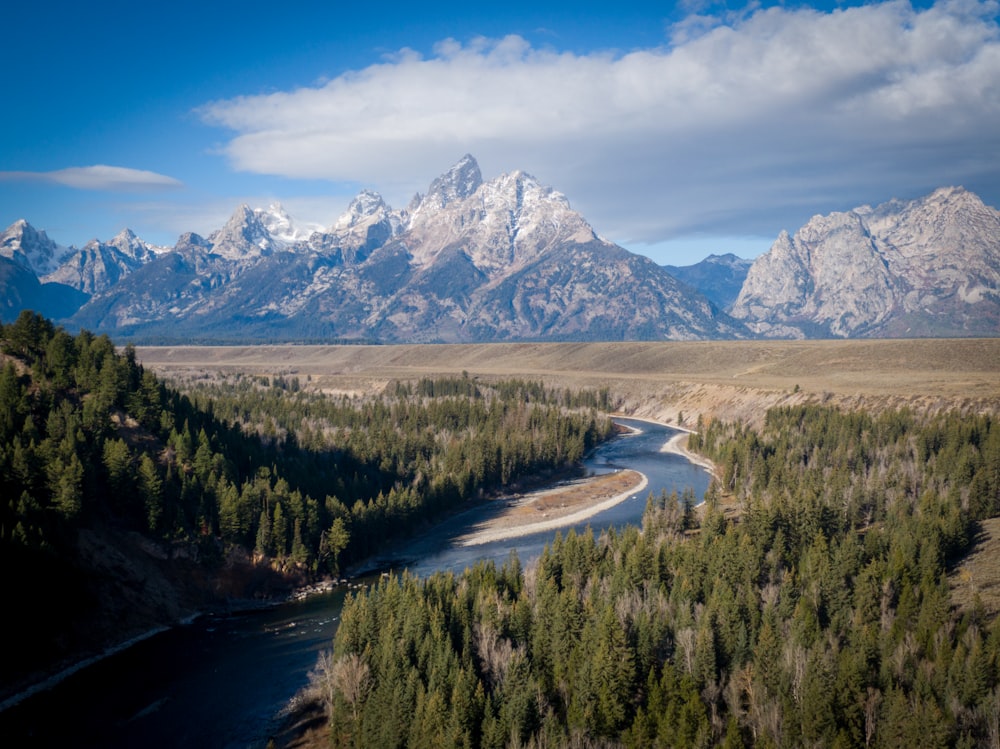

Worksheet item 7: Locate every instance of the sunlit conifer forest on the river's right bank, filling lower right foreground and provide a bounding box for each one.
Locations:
[314,407,1000,748]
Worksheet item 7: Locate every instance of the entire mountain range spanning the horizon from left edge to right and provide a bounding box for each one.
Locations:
[0,155,1000,343]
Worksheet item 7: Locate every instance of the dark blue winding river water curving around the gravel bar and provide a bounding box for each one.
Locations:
[0,419,709,749]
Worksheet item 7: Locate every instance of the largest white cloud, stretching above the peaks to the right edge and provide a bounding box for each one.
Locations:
[200,0,1000,243]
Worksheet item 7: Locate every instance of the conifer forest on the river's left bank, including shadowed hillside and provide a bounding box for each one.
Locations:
[0,312,612,688]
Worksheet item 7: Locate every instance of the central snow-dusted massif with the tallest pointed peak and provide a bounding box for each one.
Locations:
[64,156,746,342]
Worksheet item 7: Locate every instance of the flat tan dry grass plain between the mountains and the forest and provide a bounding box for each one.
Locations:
[138,338,1000,424]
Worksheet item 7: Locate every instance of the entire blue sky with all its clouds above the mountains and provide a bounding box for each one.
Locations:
[0,0,1000,265]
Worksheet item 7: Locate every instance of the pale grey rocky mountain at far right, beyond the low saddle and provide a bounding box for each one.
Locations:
[731,187,1000,338]
